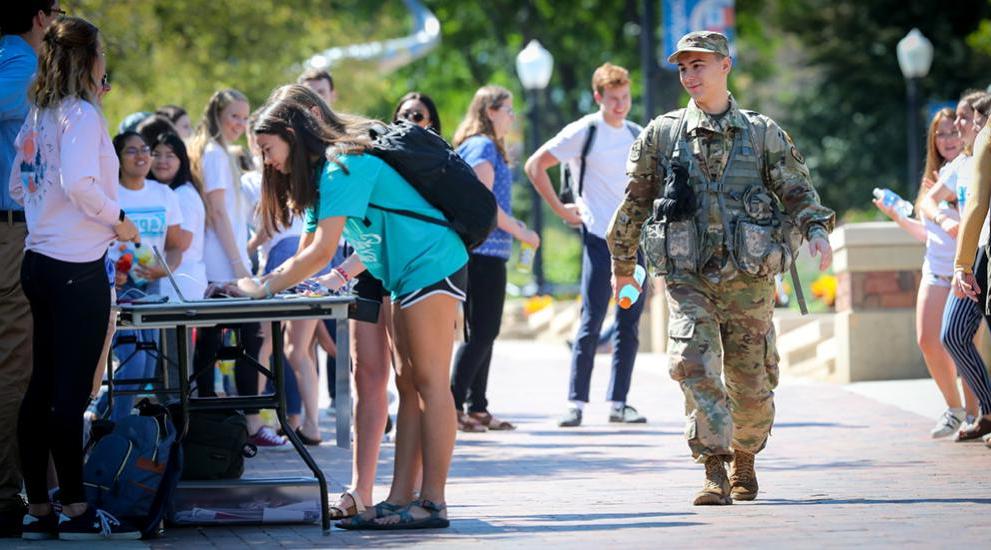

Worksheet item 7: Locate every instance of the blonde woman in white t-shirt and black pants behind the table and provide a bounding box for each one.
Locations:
[189,89,289,449]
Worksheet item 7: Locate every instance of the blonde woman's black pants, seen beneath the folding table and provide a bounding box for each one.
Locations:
[193,323,262,414]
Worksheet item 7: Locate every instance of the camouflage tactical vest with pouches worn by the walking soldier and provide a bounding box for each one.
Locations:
[641,110,798,282]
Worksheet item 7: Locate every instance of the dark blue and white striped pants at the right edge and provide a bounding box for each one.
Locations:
[940,247,991,414]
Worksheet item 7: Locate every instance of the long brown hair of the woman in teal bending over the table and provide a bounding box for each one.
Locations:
[251,99,372,234]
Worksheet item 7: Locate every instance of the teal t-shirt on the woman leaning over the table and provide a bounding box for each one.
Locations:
[305,155,468,298]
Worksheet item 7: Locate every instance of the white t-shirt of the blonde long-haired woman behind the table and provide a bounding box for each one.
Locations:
[203,141,251,281]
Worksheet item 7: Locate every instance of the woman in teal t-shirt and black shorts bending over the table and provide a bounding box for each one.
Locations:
[238,100,468,529]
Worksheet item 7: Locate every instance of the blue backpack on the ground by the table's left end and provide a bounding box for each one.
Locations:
[83,399,182,537]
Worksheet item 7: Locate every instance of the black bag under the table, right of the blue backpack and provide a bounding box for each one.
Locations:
[175,410,258,480]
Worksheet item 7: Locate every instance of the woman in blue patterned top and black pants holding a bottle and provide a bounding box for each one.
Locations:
[451,86,540,432]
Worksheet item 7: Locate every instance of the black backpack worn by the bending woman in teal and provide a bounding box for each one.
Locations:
[368,120,496,251]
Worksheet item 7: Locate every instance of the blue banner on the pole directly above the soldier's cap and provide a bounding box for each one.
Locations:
[661,0,736,71]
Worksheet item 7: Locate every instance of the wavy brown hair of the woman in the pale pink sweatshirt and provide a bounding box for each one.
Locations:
[28,17,101,109]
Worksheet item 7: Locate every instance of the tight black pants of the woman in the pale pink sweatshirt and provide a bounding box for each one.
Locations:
[17,251,110,504]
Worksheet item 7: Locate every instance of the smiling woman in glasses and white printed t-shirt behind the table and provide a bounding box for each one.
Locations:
[96,132,189,420]
